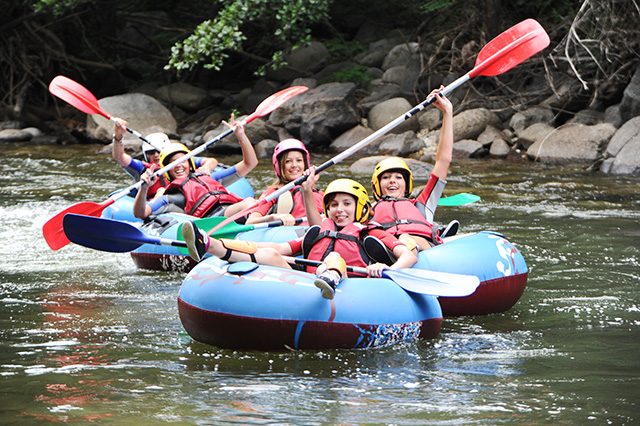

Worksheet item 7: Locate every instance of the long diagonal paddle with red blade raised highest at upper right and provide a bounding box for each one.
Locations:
[209,19,549,236]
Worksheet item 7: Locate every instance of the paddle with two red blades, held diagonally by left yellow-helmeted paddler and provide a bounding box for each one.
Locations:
[42,86,308,250]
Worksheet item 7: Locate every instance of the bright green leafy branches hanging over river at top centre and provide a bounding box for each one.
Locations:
[166,0,332,71]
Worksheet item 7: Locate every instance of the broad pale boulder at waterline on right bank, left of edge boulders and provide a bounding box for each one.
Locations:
[527,123,616,164]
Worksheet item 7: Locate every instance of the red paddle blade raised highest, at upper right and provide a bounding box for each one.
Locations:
[469,19,549,77]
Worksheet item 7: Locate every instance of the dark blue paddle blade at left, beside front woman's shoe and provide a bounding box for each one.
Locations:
[62,213,160,253]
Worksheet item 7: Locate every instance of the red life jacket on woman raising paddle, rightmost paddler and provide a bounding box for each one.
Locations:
[373,197,442,244]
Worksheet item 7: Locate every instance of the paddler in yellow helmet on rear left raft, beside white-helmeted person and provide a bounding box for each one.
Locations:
[133,114,258,219]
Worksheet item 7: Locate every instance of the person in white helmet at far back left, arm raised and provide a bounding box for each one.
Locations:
[111,118,218,198]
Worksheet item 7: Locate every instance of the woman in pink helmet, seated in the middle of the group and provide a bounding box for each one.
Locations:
[247,138,323,226]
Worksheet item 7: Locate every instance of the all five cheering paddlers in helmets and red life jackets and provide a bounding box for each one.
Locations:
[113,87,457,299]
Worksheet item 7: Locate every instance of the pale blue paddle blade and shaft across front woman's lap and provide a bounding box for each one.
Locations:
[283,256,480,297]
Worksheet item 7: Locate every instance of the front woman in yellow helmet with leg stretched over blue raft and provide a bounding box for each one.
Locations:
[182,167,418,299]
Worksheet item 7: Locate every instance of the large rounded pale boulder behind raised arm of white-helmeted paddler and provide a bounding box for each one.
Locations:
[87,93,177,140]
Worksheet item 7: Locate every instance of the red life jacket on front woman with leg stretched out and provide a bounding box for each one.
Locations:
[302,219,378,276]
